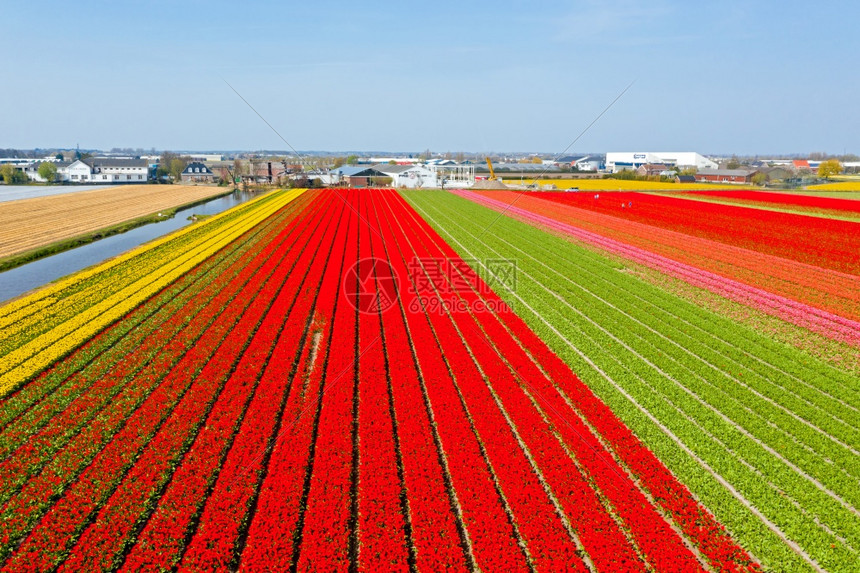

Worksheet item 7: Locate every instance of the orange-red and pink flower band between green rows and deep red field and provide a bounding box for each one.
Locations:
[463,191,860,328]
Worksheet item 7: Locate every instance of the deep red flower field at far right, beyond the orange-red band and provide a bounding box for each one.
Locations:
[530,192,860,274]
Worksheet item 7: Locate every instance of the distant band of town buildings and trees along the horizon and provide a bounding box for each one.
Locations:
[0,148,860,188]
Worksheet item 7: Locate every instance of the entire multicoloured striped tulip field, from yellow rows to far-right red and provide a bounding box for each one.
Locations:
[0,185,860,571]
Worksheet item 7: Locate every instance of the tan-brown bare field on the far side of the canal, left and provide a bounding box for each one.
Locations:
[0,185,226,259]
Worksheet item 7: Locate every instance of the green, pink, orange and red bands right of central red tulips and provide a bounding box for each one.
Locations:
[407,191,860,571]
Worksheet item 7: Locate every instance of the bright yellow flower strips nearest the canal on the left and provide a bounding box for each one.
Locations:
[0,189,304,396]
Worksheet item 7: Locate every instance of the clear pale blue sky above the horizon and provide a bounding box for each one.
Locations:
[0,0,860,154]
